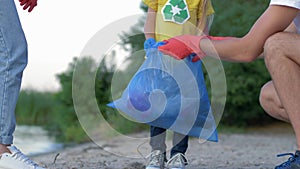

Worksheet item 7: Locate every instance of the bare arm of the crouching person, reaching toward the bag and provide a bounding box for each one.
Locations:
[200,5,299,62]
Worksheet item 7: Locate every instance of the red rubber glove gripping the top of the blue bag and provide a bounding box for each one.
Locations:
[158,35,232,62]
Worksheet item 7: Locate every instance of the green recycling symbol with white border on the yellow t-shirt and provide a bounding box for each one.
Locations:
[161,0,190,24]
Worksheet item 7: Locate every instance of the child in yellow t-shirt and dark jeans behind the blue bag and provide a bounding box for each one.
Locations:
[143,0,214,169]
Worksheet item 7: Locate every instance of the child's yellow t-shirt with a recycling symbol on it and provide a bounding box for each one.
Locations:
[143,0,214,41]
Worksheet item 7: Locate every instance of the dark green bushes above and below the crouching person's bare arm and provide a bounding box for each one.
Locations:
[210,0,274,126]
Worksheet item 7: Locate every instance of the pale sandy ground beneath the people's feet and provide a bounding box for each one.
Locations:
[33,124,296,169]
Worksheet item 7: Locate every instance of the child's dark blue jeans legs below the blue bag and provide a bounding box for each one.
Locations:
[150,126,189,157]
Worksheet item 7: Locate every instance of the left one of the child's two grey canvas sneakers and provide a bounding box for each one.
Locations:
[146,150,166,169]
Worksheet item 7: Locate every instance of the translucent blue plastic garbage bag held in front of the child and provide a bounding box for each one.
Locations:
[108,45,218,142]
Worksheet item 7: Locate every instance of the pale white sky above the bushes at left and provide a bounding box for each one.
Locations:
[15,0,143,91]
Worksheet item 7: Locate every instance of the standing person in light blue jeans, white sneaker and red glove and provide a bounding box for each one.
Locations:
[0,0,43,169]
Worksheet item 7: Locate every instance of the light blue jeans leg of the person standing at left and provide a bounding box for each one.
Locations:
[0,0,27,144]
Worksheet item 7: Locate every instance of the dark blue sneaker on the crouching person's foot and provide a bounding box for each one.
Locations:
[275,150,300,169]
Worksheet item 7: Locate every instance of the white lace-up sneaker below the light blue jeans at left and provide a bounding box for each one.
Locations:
[0,146,45,169]
